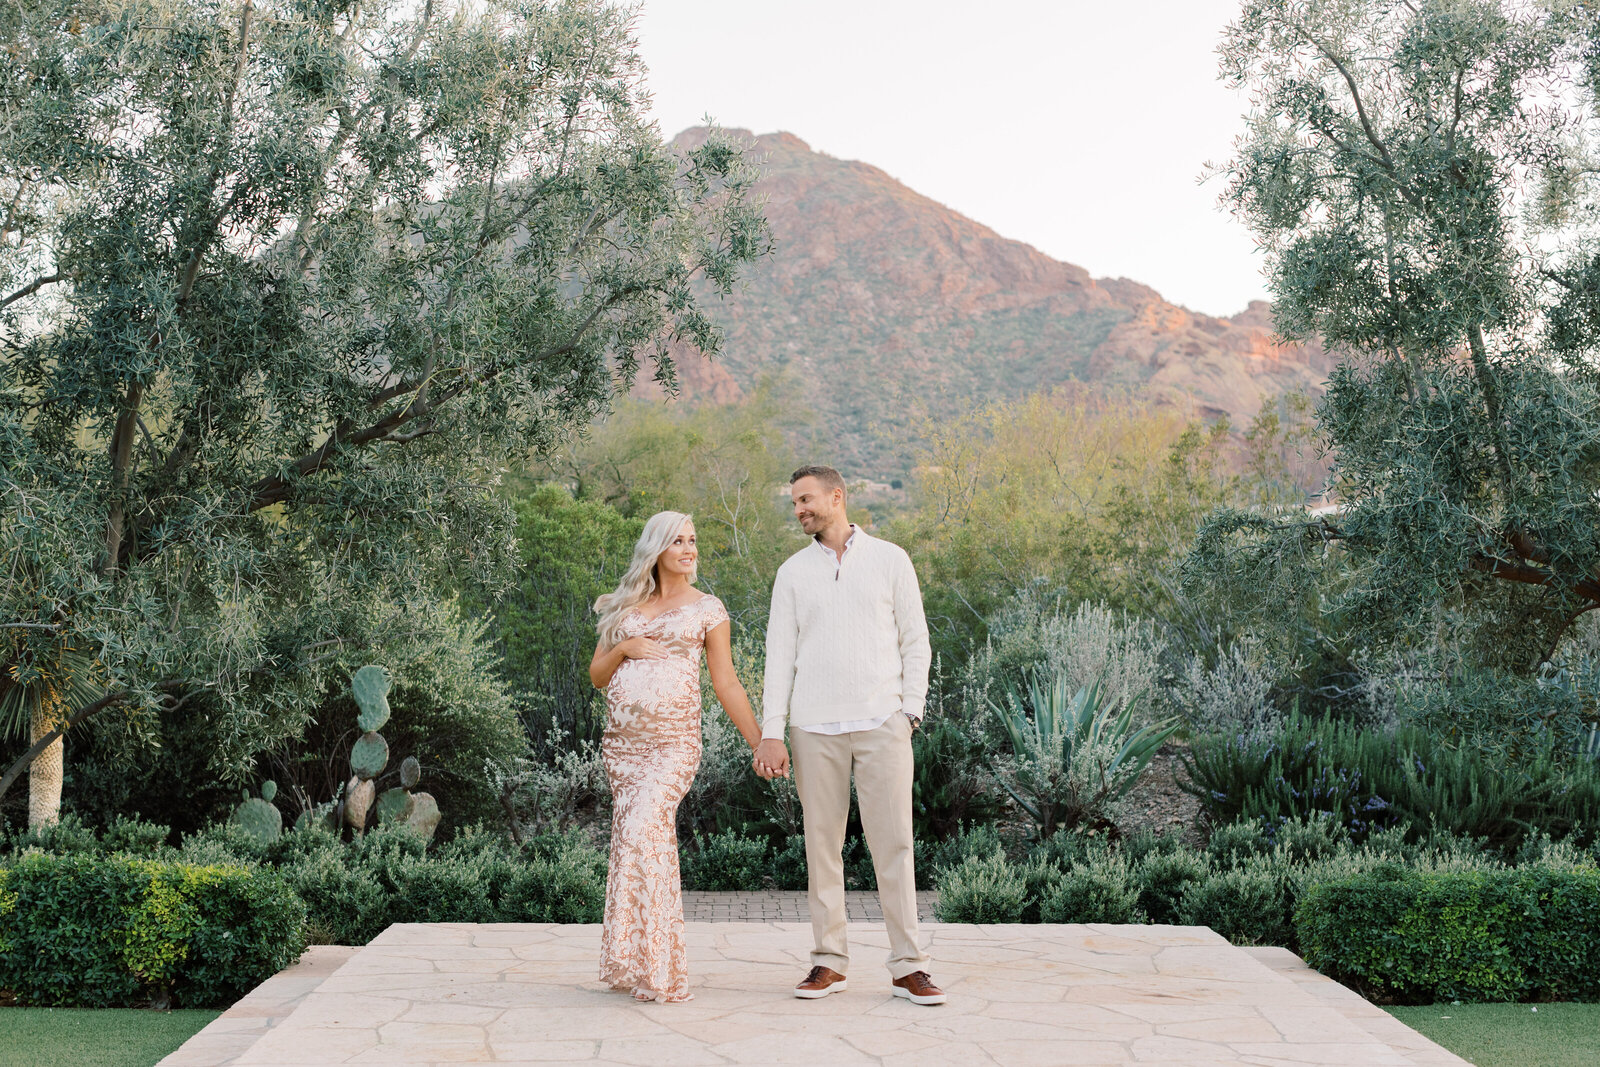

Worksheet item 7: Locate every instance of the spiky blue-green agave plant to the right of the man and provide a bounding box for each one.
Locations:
[989,673,1178,838]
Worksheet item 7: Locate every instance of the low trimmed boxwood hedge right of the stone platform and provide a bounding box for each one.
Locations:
[1296,865,1600,1003]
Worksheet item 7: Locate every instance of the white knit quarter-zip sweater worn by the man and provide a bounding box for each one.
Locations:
[762,530,933,737]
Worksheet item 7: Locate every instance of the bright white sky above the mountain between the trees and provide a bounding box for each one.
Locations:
[638,0,1267,315]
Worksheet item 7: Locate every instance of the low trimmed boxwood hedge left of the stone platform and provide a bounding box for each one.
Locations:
[0,853,306,1008]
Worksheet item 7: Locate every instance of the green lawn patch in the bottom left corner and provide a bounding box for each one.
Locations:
[0,1008,222,1067]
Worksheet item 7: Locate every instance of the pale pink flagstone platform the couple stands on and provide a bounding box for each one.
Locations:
[162,921,1466,1067]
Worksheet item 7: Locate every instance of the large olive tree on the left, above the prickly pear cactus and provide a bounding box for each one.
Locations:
[0,0,768,819]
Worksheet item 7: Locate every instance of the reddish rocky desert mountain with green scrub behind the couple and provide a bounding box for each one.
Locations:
[656,128,1333,478]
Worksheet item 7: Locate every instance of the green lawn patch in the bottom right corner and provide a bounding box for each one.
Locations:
[1387,1005,1600,1067]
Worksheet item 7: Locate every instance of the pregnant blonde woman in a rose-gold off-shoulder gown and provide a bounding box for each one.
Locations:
[589,512,762,1001]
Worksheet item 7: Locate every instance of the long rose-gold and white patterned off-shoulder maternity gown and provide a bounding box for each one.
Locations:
[600,595,728,1000]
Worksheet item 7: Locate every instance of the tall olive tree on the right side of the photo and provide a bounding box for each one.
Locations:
[1187,0,1600,677]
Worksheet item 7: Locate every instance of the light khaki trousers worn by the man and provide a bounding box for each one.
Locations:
[789,712,928,979]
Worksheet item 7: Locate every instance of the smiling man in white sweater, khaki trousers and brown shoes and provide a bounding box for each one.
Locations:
[755,467,946,1005]
